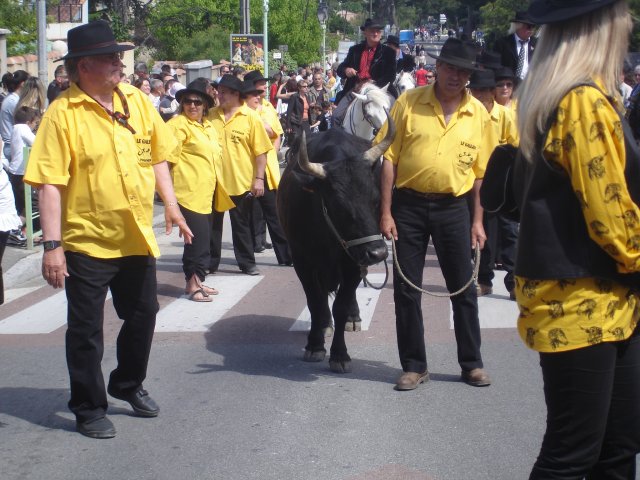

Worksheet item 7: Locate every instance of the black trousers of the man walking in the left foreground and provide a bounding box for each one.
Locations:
[65,252,159,422]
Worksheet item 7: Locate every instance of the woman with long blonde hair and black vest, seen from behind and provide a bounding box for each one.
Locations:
[515,0,640,480]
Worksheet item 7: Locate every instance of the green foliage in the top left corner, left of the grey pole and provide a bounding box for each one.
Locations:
[0,0,38,57]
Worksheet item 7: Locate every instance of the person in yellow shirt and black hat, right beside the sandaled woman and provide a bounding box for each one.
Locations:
[209,75,290,275]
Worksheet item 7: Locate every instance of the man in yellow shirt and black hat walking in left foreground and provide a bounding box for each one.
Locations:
[24,20,192,438]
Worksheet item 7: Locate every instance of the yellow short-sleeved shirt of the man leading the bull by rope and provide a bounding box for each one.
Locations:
[374,85,498,196]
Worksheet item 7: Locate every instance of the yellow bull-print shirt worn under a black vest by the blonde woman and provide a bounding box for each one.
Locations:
[516,86,640,352]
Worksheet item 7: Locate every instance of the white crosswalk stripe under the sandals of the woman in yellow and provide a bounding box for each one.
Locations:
[156,275,264,332]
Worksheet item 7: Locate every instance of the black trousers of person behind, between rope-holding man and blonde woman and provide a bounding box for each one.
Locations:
[478,212,518,291]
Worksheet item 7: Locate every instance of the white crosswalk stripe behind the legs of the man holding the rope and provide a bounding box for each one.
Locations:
[449,270,520,329]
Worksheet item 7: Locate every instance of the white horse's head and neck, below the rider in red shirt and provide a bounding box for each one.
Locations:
[342,82,394,140]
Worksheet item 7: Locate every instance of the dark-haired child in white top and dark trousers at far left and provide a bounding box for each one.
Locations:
[7,107,42,220]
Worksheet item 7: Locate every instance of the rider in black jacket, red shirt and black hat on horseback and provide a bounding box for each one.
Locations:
[333,18,398,125]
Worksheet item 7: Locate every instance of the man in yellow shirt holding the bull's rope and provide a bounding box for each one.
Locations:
[374,38,493,390]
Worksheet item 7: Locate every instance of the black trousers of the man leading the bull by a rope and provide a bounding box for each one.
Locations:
[391,190,483,372]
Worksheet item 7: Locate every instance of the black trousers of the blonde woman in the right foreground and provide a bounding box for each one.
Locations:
[529,327,640,480]
